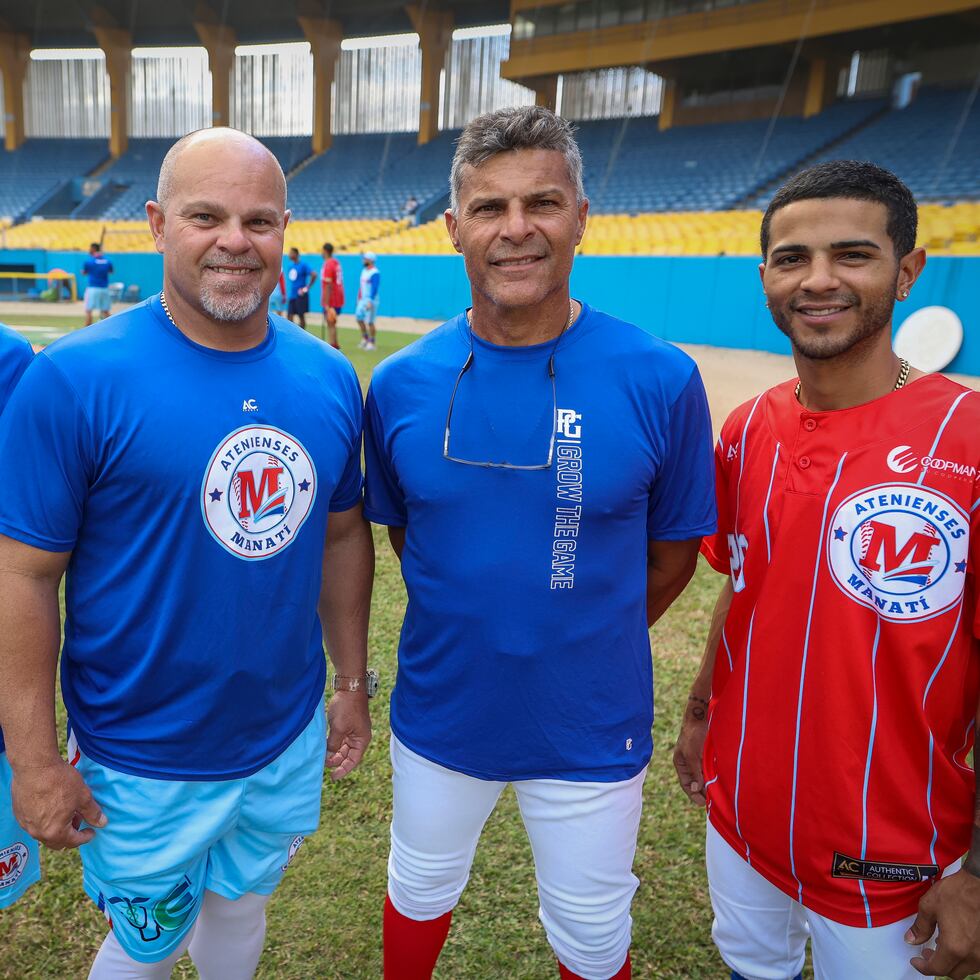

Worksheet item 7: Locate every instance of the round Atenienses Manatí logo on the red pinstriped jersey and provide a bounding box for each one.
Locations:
[827,483,970,623]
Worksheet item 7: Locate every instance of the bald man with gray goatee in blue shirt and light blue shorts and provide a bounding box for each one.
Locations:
[0,128,374,980]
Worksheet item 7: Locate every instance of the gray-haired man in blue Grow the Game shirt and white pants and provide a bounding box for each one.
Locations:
[365,106,715,980]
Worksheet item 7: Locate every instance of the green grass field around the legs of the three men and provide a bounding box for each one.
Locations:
[0,330,772,980]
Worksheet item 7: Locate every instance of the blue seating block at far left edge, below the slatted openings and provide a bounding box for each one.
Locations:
[0,139,109,220]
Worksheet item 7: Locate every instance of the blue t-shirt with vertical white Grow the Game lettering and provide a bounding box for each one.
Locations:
[365,306,715,781]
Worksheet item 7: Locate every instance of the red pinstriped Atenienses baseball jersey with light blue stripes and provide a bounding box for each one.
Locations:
[703,375,980,926]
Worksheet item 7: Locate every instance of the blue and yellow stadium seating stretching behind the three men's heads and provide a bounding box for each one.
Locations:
[0,89,980,255]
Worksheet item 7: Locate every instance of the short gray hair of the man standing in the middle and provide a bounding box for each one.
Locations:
[449,105,585,214]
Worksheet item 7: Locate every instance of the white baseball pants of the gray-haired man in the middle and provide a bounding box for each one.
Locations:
[388,735,646,980]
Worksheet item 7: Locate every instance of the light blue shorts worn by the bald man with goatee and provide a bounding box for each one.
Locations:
[69,701,327,963]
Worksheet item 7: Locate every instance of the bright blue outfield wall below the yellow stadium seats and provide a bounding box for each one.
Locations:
[0,250,980,375]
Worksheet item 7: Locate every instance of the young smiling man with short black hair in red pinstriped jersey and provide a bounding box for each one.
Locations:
[674,161,980,980]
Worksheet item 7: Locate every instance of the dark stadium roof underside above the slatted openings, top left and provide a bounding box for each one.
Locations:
[0,0,510,48]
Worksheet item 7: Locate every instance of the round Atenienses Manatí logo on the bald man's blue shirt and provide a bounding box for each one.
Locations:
[201,425,316,561]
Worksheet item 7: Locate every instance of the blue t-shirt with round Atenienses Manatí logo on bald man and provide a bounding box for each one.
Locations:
[0,296,362,779]
